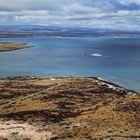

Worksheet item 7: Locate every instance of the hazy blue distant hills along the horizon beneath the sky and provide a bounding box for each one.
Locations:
[0,25,140,37]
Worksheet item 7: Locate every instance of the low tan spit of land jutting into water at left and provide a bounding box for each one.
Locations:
[0,42,32,52]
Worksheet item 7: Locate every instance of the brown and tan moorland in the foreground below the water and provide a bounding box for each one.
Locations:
[0,77,140,140]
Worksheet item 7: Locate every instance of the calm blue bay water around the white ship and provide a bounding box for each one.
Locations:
[0,37,140,92]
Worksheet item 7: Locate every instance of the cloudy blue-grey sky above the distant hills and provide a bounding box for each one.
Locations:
[0,0,140,30]
